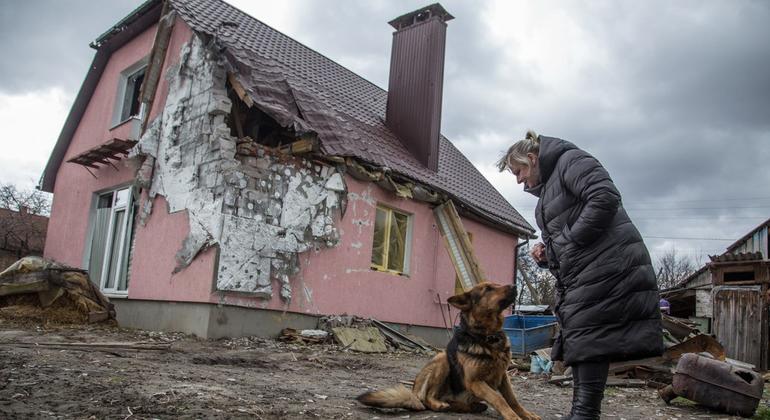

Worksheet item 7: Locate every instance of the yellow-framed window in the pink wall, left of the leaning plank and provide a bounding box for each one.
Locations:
[372,206,411,274]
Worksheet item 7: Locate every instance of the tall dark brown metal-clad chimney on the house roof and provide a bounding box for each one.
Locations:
[385,3,453,171]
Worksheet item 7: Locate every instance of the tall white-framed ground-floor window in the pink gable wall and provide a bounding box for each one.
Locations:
[88,188,135,293]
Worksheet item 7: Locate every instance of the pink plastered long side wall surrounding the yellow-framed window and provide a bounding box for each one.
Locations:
[210,177,517,327]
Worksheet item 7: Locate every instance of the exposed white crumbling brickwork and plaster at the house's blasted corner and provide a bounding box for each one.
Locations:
[131,36,346,301]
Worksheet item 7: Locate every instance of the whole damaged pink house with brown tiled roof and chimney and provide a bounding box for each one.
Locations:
[40,0,534,344]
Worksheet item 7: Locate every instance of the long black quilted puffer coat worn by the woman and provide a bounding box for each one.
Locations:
[527,136,663,365]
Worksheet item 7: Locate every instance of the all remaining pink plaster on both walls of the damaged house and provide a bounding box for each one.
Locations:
[45,14,516,327]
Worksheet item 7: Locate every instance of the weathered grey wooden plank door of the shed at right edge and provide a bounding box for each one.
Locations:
[713,286,763,367]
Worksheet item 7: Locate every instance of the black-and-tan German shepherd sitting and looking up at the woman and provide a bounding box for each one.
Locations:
[357,282,540,420]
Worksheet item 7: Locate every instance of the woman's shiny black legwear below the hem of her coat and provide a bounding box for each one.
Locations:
[567,360,610,420]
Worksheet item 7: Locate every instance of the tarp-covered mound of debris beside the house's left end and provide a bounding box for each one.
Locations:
[0,257,115,323]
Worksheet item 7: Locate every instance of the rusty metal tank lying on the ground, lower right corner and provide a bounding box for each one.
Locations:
[659,353,764,417]
